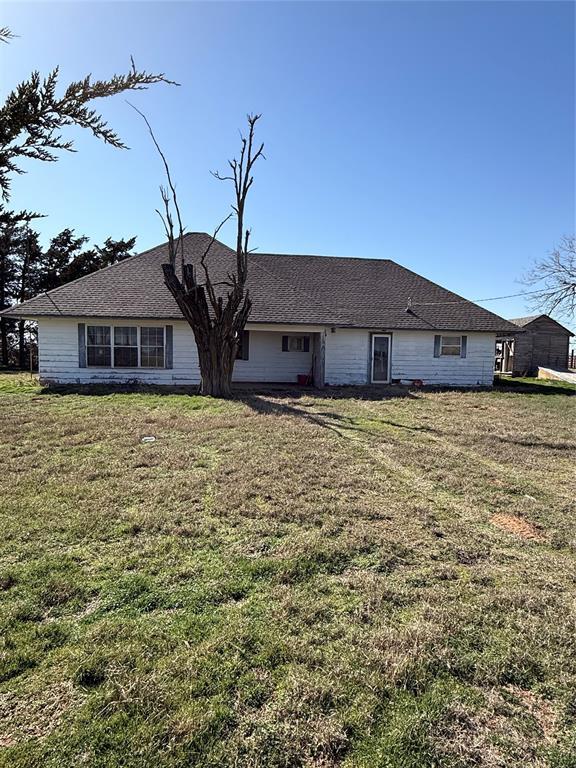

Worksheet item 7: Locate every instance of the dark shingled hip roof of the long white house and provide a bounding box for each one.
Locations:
[2,232,514,332]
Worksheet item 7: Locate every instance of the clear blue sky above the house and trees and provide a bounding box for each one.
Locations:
[0,0,575,317]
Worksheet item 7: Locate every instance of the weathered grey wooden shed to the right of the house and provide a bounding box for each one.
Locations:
[496,315,574,376]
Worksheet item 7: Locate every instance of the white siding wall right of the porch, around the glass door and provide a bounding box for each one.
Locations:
[325,328,496,387]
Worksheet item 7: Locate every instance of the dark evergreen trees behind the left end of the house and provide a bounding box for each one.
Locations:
[0,223,136,368]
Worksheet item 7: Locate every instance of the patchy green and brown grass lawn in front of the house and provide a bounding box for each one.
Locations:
[0,375,576,768]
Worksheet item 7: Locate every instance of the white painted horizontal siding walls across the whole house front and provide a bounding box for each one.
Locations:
[38,318,495,386]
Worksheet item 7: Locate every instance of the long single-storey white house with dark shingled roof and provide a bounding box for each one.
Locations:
[4,233,516,387]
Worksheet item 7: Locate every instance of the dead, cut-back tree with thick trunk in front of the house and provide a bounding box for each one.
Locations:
[135,108,264,397]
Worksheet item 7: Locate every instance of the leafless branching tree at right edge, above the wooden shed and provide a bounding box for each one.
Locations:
[522,236,576,317]
